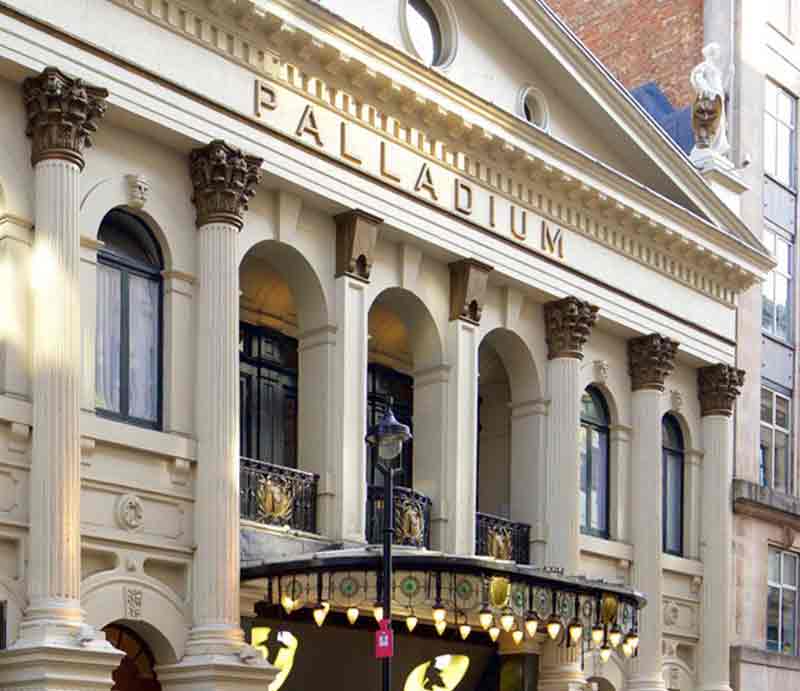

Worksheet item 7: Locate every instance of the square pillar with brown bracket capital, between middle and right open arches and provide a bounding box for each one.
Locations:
[440,259,492,555]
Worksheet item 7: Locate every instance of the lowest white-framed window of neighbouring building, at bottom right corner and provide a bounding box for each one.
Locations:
[767,547,800,655]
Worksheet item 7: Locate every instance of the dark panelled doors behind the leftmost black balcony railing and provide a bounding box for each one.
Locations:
[239,322,298,468]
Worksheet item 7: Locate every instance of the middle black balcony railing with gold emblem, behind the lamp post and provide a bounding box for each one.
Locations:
[367,485,431,548]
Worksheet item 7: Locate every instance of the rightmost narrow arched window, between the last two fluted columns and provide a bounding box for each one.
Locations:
[661,415,684,556]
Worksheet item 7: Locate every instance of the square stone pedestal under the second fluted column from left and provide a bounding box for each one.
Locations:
[156,646,278,691]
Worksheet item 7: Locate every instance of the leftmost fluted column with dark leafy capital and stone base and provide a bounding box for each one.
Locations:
[0,68,121,689]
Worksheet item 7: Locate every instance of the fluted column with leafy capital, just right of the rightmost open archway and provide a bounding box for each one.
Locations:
[544,297,598,575]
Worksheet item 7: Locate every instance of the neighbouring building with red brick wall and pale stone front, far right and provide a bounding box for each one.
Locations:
[550,0,800,690]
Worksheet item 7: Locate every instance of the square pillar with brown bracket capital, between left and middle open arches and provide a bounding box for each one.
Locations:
[325,209,382,544]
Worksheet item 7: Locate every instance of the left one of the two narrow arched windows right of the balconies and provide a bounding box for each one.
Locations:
[579,386,609,538]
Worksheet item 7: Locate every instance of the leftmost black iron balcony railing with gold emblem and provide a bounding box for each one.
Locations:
[239,458,319,533]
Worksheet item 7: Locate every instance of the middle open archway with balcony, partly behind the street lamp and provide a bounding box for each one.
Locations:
[366,288,443,547]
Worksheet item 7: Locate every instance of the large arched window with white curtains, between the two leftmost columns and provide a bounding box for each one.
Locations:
[95,209,163,428]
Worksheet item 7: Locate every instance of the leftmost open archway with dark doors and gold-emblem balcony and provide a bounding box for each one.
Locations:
[239,241,327,532]
